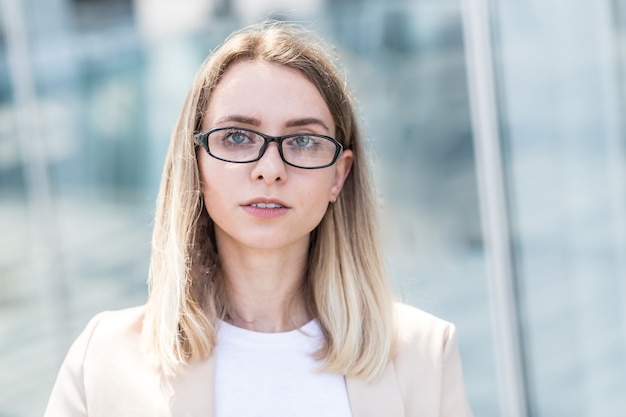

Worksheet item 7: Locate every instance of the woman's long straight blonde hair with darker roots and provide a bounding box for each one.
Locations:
[143,22,393,379]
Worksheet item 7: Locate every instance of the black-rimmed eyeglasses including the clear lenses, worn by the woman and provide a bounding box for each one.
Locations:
[194,127,343,169]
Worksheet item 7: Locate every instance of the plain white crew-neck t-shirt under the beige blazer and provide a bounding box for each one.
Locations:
[215,320,352,417]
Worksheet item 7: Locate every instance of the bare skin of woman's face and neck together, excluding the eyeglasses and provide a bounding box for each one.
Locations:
[197,61,353,332]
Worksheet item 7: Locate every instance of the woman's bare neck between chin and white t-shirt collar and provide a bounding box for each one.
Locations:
[220,237,312,333]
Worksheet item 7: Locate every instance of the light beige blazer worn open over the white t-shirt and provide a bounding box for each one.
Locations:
[45,304,472,417]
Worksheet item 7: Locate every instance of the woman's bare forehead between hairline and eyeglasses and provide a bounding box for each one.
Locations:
[203,61,334,133]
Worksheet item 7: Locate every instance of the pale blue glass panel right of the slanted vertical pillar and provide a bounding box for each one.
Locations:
[494,1,626,417]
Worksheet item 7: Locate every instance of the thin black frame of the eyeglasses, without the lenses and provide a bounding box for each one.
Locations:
[194,126,343,169]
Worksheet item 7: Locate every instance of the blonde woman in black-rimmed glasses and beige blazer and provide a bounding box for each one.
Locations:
[46,23,471,417]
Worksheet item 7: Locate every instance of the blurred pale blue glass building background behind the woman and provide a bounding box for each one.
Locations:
[0,0,626,417]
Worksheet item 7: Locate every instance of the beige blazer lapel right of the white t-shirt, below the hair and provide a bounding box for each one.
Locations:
[346,361,404,417]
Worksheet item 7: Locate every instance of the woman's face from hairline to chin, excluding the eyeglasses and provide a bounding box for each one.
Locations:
[197,61,352,250]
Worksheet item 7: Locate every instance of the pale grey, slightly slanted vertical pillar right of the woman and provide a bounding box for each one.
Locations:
[462,0,529,417]
